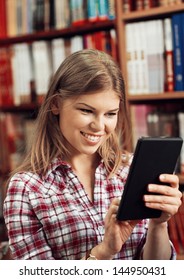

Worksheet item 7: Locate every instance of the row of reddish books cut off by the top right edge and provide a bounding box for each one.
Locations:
[123,0,184,13]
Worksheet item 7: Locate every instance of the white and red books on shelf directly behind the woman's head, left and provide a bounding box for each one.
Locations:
[0,29,117,107]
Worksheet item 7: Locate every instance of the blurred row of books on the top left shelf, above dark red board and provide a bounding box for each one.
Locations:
[0,0,115,38]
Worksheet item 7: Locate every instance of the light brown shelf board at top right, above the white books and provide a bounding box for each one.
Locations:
[121,4,184,22]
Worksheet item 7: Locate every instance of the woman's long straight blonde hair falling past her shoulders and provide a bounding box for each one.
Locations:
[11,49,130,175]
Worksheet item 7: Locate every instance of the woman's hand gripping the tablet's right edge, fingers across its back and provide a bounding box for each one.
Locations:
[144,174,182,223]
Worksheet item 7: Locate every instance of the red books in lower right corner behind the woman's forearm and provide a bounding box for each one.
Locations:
[168,195,184,255]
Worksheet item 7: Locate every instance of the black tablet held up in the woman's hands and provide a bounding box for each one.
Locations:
[117,137,183,221]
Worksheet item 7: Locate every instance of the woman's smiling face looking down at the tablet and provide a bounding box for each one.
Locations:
[57,90,120,158]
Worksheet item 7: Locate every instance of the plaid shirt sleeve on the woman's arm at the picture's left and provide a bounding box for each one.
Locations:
[4,176,54,260]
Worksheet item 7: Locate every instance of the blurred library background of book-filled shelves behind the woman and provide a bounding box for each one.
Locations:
[0,0,184,260]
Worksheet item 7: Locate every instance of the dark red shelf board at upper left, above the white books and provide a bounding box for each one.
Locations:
[0,20,115,47]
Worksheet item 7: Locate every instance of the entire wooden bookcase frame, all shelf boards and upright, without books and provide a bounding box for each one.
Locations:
[0,0,184,259]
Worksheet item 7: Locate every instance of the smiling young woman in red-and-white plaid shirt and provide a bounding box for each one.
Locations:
[4,50,181,260]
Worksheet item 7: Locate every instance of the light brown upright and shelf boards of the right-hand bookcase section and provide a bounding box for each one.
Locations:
[116,0,184,259]
